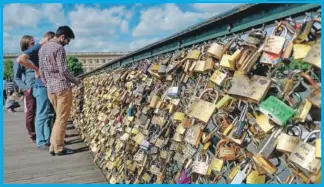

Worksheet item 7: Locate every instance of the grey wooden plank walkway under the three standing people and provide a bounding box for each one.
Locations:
[4,108,107,184]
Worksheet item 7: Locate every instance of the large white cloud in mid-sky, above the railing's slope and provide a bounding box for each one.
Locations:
[133,4,212,36]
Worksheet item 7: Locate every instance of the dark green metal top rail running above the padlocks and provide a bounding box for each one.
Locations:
[80,3,321,77]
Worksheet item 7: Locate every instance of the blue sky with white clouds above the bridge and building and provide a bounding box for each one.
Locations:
[3,3,239,53]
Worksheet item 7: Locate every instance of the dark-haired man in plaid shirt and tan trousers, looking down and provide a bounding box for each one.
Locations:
[38,26,81,156]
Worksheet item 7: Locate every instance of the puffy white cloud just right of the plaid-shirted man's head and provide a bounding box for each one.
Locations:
[69,5,131,38]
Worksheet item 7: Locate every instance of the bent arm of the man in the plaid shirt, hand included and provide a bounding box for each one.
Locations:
[56,46,80,84]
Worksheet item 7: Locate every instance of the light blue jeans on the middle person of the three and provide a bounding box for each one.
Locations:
[33,86,53,146]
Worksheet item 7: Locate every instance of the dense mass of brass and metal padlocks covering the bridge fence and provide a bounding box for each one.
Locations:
[72,14,321,184]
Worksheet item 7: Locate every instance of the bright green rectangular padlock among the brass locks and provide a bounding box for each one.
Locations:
[259,96,295,126]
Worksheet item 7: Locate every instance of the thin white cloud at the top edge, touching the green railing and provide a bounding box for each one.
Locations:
[192,3,240,12]
